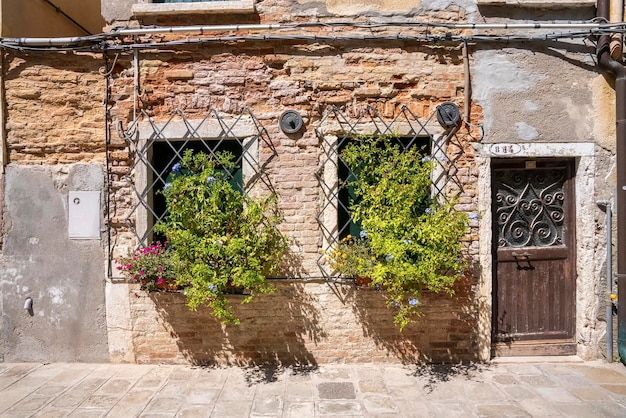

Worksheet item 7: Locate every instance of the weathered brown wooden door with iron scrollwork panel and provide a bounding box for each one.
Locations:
[492,159,576,355]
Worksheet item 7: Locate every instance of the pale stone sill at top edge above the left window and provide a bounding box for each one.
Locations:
[132,0,255,16]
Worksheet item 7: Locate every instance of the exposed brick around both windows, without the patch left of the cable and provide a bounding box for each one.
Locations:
[103,23,480,363]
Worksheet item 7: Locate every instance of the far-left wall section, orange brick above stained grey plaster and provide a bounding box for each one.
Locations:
[0,52,109,362]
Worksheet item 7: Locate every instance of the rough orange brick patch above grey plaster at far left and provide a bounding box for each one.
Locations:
[4,53,105,165]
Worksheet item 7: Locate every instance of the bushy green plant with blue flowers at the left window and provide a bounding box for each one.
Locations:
[155,150,287,323]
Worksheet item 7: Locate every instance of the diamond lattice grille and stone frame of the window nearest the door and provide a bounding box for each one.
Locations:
[315,106,465,278]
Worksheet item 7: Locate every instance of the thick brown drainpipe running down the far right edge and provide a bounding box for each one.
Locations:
[597,0,626,364]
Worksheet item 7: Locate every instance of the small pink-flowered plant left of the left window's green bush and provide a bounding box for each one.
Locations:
[117,242,175,292]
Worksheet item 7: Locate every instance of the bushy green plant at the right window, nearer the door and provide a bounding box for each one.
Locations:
[329,136,468,330]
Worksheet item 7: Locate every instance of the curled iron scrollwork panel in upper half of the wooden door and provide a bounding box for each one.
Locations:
[494,168,566,247]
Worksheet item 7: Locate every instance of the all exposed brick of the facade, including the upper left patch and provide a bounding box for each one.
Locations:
[6,7,480,364]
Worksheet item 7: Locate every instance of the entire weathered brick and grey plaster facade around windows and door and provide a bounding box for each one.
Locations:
[0,0,614,364]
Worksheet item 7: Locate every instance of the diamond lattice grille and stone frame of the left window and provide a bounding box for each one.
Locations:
[115,109,276,246]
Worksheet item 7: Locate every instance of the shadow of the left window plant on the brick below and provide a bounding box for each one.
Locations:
[150,283,326,368]
